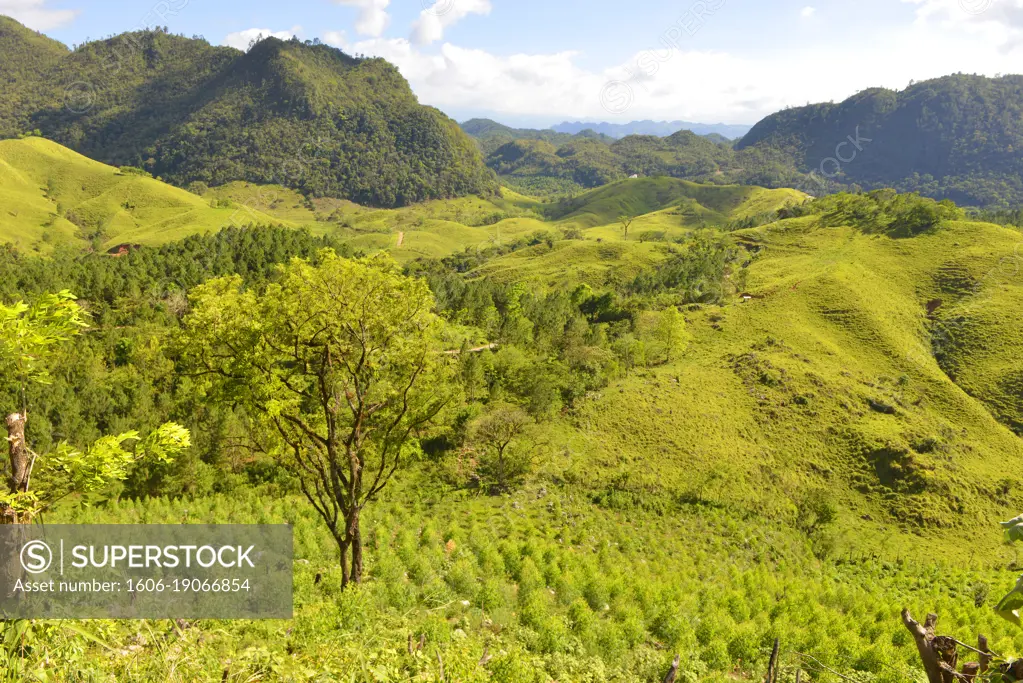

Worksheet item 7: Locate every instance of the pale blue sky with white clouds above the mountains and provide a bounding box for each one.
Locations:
[0,0,1023,127]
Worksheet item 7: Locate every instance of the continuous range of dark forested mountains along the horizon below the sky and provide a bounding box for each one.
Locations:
[7,16,1023,208]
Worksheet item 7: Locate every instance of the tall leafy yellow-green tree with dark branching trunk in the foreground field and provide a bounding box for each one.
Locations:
[182,251,447,585]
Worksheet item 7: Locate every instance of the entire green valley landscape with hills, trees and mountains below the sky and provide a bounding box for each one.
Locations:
[0,10,1023,683]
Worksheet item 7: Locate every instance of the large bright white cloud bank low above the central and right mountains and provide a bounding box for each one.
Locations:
[324,9,1023,123]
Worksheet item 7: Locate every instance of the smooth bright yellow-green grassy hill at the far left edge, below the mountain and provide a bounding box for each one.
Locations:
[0,138,288,252]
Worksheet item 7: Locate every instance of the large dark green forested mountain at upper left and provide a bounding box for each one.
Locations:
[0,19,496,207]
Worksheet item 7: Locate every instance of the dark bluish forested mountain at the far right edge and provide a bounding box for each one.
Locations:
[736,74,1023,206]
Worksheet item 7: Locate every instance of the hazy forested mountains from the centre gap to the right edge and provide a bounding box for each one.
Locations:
[463,75,1023,208]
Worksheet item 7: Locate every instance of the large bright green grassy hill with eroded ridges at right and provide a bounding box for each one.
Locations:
[560,219,1023,556]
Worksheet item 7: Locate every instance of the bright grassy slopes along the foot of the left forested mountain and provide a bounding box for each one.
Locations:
[0,138,544,261]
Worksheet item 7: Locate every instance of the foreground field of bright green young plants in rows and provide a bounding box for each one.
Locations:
[9,482,1023,683]
